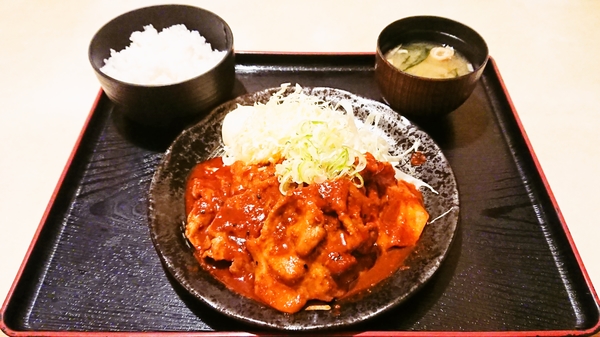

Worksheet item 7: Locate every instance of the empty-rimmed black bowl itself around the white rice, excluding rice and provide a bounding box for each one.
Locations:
[88,5,235,129]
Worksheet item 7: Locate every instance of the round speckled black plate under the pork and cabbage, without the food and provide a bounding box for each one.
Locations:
[149,88,459,330]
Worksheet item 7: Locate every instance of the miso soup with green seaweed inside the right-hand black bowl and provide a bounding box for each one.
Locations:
[385,42,473,78]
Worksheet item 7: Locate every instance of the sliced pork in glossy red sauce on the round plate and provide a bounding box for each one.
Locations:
[185,154,428,313]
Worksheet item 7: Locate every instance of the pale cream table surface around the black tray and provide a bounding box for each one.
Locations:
[0,0,600,335]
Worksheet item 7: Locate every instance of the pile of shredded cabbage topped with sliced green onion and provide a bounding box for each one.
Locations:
[222,84,428,194]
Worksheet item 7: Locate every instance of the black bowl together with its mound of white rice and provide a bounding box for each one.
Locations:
[89,5,235,129]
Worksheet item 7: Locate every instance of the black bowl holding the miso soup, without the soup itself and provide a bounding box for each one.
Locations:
[375,16,489,121]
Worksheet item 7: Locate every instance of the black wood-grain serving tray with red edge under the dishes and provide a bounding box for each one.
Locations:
[2,54,600,335]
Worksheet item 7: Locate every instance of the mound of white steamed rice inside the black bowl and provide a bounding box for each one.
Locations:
[100,24,226,85]
